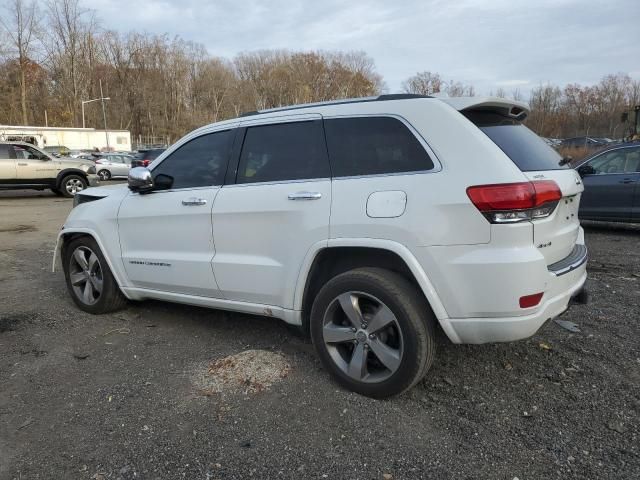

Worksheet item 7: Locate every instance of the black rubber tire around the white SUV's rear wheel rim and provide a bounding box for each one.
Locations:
[310,268,436,398]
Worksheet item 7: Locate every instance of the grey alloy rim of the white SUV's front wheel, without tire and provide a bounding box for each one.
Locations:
[69,246,104,305]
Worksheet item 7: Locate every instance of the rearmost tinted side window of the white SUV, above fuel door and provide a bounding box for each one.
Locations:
[324,117,434,177]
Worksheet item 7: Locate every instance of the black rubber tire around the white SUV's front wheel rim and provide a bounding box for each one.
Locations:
[62,236,127,314]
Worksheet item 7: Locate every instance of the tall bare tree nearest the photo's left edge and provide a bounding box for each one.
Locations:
[0,0,38,125]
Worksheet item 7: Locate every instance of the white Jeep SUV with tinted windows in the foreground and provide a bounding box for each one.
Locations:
[58,95,587,397]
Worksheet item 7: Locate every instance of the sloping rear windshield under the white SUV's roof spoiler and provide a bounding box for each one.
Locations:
[462,110,569,172]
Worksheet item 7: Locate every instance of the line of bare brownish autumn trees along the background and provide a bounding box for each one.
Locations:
[0,0,640,142]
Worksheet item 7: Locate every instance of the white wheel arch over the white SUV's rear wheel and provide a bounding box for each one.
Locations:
[294,238,460,343]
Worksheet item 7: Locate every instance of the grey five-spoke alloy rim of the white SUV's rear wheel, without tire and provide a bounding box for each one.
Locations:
[322,291,403,383]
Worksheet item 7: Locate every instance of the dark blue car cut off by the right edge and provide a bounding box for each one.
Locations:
[577,142,640,223]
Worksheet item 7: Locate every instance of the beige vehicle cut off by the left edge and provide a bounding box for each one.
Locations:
[0,142,98,197]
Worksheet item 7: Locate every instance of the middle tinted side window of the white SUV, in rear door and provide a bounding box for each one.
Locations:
[236,120,330,183]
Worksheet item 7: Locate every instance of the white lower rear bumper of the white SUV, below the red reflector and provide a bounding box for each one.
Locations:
[449,261,587,343]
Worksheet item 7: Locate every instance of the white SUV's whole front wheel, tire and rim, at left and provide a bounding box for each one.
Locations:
[62,236,127,314]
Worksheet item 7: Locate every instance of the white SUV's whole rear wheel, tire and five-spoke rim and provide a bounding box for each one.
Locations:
[311,268,436,398]
